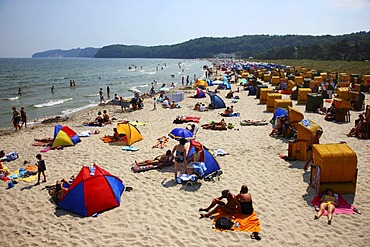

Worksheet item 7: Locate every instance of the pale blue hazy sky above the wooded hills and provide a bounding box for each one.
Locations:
[0,0,370,58]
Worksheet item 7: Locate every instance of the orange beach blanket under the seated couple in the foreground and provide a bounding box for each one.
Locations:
[213,210,261,232]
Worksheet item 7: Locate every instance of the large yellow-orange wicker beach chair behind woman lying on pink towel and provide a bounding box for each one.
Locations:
[311,144,357,194]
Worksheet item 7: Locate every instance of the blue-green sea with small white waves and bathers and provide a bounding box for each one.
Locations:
[0,58,212,129]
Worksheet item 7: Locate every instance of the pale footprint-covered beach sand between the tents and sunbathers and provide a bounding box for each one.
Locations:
[0,83,370,246]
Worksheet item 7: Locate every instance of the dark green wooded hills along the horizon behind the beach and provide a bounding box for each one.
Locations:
[95,32,370,61]
